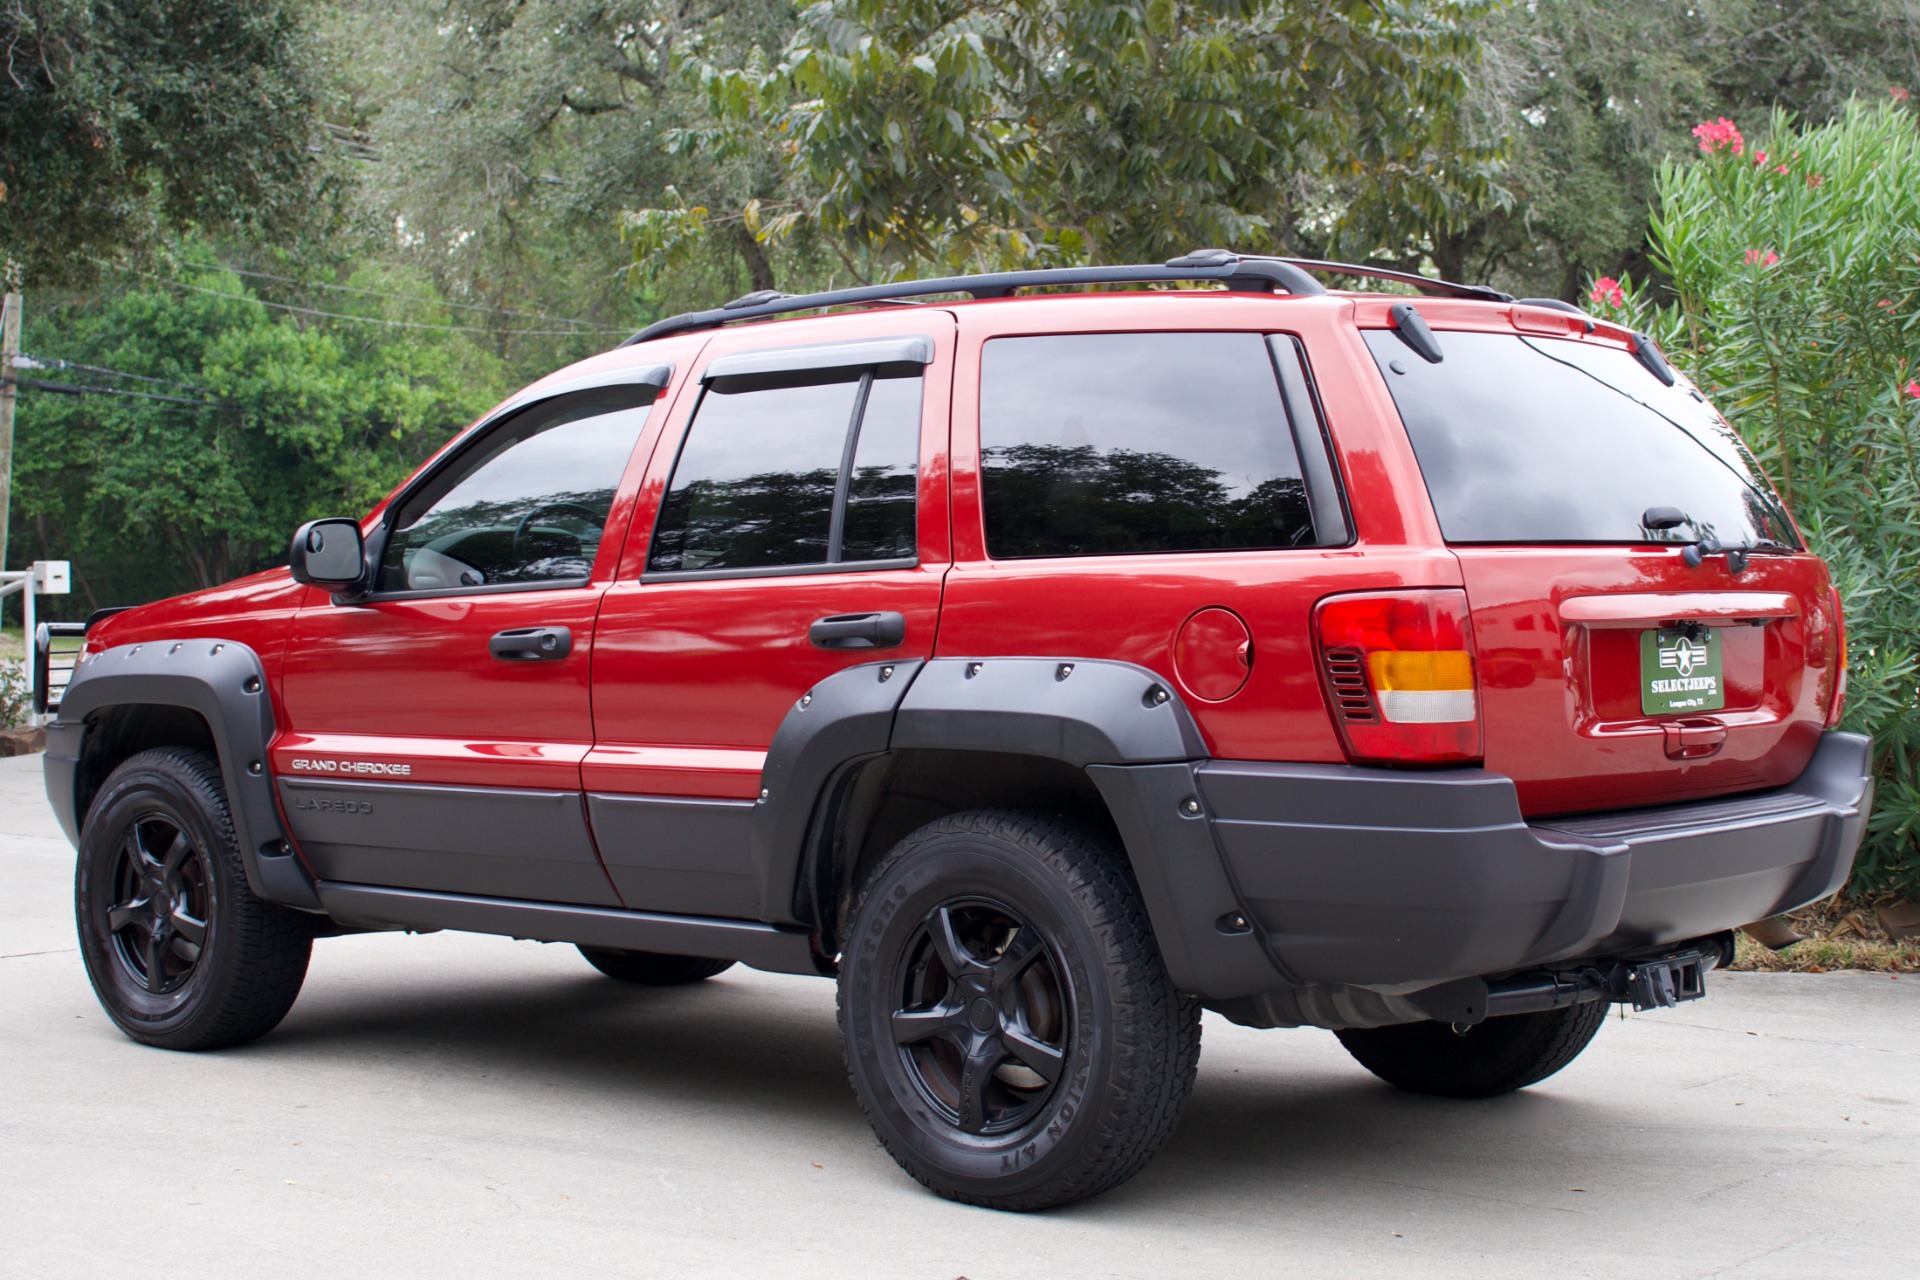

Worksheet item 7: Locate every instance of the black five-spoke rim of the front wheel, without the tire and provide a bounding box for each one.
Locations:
[108,814,211,996]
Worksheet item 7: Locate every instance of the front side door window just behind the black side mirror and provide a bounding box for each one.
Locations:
[374,386,657,593]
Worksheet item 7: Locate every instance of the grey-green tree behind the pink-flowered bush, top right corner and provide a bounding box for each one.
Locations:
[1430,0,1920,299]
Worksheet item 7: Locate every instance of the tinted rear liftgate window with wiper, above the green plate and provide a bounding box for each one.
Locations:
[1365,330,1799,547]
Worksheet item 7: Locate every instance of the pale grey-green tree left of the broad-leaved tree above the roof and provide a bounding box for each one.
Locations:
[326,0,810,339]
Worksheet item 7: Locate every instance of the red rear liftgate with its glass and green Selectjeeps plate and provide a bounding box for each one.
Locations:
[1365,330,1837,814]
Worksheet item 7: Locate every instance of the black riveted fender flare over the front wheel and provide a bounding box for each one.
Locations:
[46,637,321,912]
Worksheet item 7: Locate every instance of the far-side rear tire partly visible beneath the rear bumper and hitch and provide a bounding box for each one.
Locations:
[1334,1000,1609,1098]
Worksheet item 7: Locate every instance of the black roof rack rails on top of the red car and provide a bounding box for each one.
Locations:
[620,249,1511,347]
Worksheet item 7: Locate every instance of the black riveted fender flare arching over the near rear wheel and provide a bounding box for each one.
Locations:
[753,658,1275,996]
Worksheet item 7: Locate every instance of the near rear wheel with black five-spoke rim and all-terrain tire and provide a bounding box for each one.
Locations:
[839,810,1200,1211]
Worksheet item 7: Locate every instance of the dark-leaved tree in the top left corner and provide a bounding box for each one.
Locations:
[0,0,319,286]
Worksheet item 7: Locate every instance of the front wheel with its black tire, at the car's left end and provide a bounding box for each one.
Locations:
[73,747,313,1050]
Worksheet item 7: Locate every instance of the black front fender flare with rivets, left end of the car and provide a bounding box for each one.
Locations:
[46,637,321,912]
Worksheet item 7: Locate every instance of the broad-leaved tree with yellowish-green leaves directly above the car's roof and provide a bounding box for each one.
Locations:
[652,0,1496,273]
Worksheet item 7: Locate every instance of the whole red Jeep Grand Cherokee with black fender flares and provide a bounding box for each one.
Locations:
[38,249,1870,1209]
